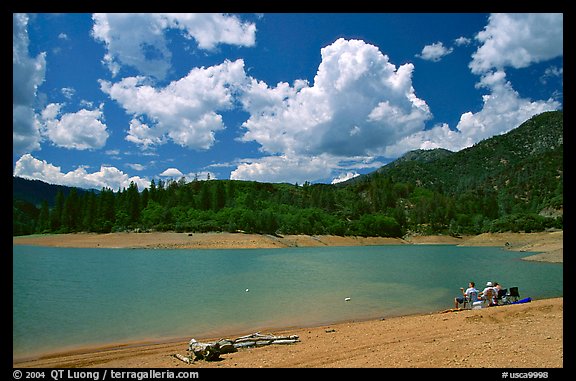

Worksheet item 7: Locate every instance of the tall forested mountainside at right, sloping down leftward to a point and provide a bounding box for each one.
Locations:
[346,111,564,203]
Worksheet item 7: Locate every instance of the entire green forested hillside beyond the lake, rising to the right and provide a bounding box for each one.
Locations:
[13,111,563,236]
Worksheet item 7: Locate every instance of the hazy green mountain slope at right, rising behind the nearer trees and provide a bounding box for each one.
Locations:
[344,111,564,194]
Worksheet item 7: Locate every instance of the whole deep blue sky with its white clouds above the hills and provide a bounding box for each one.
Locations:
[13,13,563,190]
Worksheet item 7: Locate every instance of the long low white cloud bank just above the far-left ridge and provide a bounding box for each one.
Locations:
[14,154,150,190]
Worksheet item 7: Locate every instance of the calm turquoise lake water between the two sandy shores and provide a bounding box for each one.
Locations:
[12,245,563,358]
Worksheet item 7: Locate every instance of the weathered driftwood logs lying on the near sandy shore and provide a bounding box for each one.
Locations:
[182,332,300,363]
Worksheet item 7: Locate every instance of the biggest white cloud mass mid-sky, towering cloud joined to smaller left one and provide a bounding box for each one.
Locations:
[100,39,418,182]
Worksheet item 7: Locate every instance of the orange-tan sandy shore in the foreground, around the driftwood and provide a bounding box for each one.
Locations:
[13,297,564,370]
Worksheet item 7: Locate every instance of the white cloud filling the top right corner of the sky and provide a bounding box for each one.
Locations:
[470,13,564,74]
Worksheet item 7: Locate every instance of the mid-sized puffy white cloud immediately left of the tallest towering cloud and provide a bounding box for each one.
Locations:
[100,59,246,150]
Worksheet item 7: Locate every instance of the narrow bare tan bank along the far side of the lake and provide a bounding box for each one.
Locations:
[12,230,564,263]
